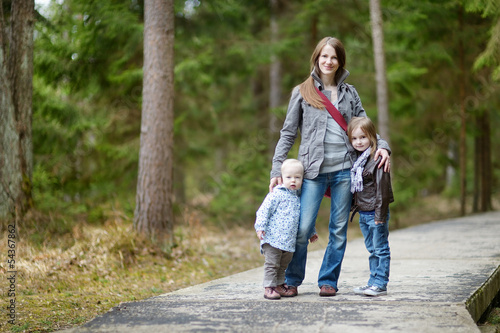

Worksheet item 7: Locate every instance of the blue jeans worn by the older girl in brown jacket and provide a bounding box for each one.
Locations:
[359,212,391,290]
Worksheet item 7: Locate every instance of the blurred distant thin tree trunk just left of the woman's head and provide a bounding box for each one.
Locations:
[269,0,281,157]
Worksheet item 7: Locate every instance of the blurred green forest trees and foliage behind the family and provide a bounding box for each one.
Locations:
[28,0,500,228]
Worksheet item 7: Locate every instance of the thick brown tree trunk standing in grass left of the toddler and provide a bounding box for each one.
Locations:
[134,0,174,244]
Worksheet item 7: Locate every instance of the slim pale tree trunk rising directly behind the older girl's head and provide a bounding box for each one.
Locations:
[370,0,390,145]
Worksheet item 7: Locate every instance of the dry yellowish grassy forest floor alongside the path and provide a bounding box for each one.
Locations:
[0,197,500,332]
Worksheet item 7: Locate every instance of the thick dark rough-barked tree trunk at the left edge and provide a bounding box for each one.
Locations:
[0,0,35,218]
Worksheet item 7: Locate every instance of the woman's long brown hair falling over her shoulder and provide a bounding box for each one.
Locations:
[299,37,345,109]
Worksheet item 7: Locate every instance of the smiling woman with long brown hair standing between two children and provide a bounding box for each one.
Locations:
[269,37,390,297]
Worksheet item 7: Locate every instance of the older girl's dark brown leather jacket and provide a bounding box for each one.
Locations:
[353,157,394,221]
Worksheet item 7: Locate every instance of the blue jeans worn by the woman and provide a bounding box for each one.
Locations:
[286,170,352,290]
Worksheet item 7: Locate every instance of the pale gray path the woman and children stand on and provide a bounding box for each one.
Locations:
[63,212,500,333]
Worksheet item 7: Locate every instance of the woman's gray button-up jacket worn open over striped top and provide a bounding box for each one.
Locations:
[271,69,390,179]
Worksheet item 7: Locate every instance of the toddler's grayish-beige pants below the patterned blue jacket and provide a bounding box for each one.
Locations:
[262,244,293,287]
